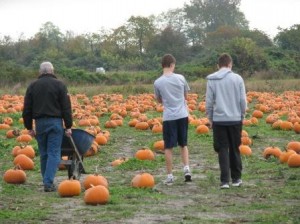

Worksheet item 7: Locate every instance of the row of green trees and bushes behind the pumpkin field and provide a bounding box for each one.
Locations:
[0,0,300,84]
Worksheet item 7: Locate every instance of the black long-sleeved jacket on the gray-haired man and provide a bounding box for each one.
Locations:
[22,74,73,130]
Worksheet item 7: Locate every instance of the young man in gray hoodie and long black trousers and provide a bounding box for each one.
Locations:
[205,54,247,189]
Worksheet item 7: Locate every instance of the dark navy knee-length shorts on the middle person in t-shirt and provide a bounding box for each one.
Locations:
[163,117,189,149]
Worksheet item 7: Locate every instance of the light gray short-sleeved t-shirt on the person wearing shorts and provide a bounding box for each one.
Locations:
[154,73,190,121]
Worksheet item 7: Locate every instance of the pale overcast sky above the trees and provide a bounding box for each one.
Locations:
[0,0,300,38]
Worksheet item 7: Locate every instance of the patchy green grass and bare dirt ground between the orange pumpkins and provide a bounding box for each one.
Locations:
[0,81,300,224]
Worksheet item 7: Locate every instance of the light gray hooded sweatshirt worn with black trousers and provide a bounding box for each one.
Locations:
[205,67,247,123]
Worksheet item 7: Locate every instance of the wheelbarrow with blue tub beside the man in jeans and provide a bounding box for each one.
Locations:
[60,129,95,180]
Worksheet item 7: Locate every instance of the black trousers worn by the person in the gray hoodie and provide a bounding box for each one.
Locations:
[213,124,242,183]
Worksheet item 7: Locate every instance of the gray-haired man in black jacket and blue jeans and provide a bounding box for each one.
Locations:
[22,62,73,192]
